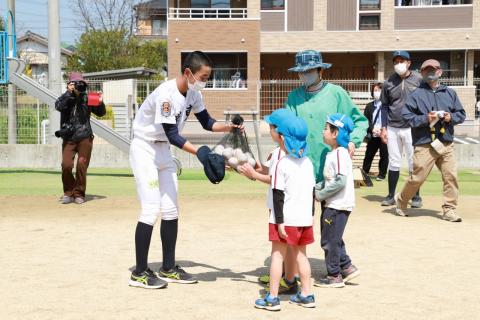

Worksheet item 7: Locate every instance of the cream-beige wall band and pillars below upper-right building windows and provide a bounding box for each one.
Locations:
[260,0,480,52]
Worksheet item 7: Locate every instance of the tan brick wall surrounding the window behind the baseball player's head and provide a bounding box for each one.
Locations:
[168,20,260,117]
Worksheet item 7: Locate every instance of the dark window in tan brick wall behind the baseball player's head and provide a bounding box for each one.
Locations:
[182,52,248,89]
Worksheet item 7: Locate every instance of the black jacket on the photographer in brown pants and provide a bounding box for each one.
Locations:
[55,91,106,141]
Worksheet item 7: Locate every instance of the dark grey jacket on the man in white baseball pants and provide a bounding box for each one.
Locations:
[380,71,422,128]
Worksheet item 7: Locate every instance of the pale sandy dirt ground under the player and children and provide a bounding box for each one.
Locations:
[0,196,480,320]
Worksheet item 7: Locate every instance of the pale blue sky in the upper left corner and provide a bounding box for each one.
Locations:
[0,0,82,45]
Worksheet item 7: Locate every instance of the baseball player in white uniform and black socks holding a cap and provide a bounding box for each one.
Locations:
[129,51,243,289]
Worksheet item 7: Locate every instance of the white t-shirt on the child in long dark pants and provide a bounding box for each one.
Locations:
[323,147,355,211]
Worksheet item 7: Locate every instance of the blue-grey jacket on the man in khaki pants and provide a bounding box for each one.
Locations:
[402,82,465,146]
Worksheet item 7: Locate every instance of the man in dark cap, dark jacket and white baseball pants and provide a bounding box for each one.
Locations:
[380,50,422,208]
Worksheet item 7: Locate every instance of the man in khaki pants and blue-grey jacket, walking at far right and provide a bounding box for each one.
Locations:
[395,59,465,222]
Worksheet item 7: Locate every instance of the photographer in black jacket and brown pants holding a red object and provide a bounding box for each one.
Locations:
[55,72,106,204]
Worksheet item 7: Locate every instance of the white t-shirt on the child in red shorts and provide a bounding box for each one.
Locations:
[269,155,315,227]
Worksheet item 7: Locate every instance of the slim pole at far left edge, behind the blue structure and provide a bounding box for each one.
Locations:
[7,0,17,144]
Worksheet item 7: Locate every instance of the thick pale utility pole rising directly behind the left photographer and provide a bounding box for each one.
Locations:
[48,0,62,143]
